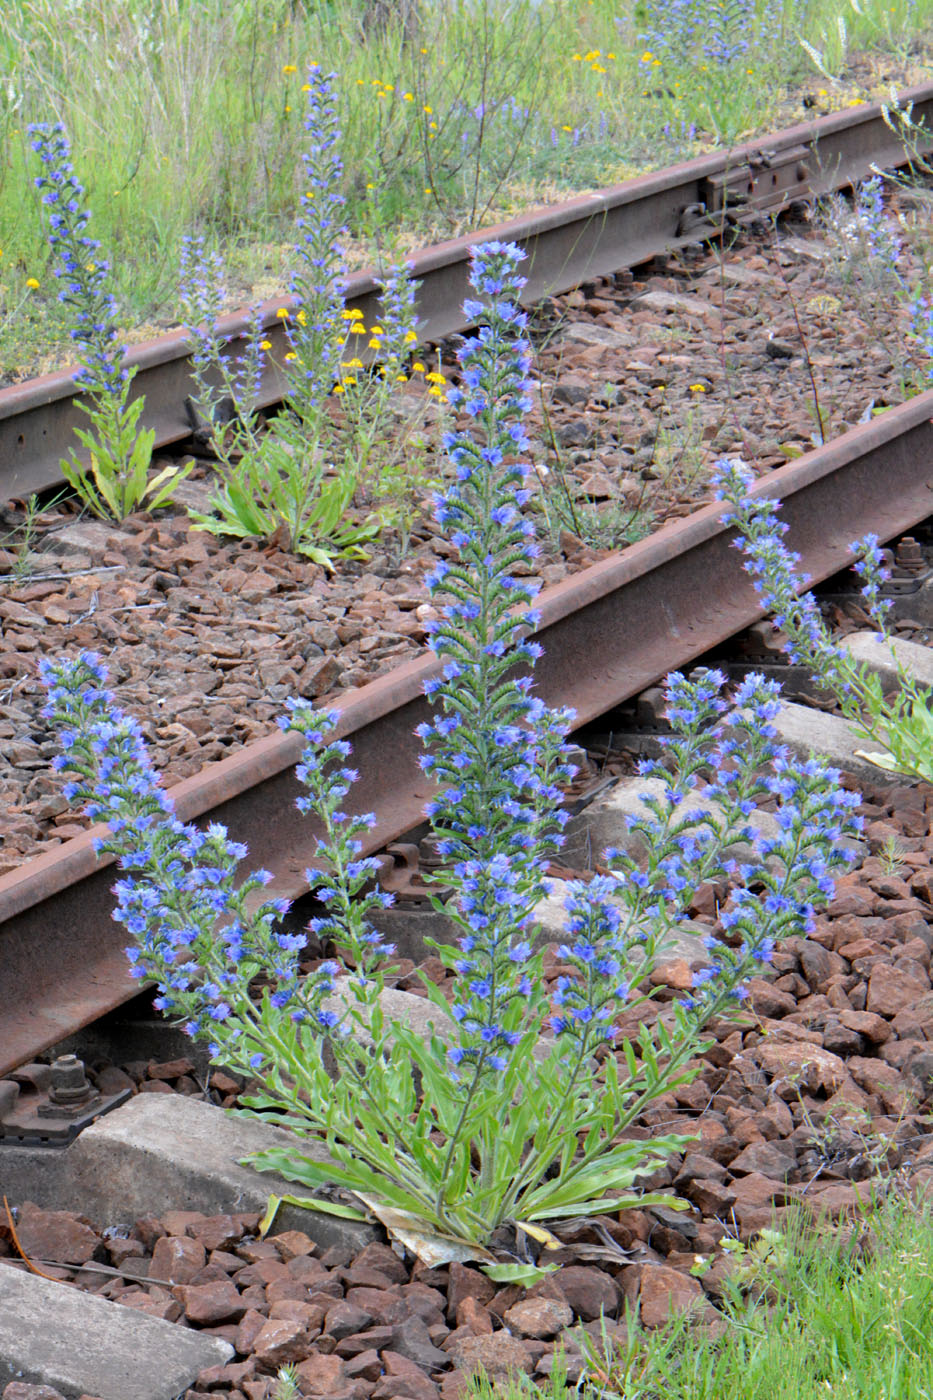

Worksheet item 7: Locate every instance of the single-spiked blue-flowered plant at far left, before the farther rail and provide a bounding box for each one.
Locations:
[29,122,187,521]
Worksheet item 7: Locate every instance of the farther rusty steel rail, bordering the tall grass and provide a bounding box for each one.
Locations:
[0,85,933,498]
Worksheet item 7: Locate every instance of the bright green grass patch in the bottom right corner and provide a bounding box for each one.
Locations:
[474,1200,933,1400]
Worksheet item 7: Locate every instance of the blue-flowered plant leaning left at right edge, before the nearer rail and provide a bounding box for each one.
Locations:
[716,458,933,780]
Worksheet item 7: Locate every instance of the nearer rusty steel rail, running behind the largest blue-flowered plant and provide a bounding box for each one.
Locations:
[0,392,933,1077]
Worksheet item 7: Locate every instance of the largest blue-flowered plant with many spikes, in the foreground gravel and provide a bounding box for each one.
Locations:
[43,242,857,1278]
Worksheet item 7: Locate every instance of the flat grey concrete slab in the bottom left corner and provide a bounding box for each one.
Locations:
[0,1271,233,1400]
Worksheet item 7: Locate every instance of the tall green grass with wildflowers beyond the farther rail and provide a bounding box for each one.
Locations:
[0,0,933,382]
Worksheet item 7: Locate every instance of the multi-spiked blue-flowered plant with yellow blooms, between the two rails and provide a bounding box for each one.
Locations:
[181,67,389,568]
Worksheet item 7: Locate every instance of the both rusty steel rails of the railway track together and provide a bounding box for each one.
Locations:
[0,88,933,1074]
